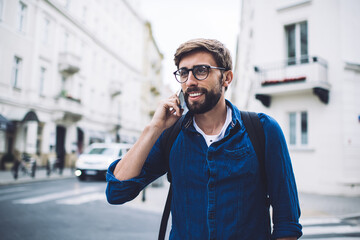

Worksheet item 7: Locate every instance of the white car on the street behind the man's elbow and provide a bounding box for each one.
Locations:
[75,143,132,181]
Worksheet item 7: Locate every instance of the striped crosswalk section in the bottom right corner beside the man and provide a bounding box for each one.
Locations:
[301,218,360,240]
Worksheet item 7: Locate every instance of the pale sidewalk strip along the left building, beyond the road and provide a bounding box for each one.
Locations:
[0,168,75,186]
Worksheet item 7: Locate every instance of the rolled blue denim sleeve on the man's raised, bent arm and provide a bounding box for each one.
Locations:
[106,133,167,204]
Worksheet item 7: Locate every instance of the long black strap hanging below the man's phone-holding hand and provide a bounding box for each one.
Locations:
[158,115,185,240]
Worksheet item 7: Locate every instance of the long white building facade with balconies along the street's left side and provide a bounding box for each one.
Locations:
[0,0,163,169]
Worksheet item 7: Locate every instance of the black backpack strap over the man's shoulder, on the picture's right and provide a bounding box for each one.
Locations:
[241,111,267,191]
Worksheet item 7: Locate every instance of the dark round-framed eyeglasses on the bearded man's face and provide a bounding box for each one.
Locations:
[174,65,228,83]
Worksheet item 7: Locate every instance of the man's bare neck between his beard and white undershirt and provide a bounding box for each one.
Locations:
[195,96,226,135]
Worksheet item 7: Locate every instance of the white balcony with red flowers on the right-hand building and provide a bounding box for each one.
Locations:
[254,56,331,107]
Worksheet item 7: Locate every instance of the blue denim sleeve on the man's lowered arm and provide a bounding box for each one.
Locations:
[259,114,302,239]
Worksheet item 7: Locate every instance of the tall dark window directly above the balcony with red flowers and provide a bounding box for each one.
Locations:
[285,22,309,65]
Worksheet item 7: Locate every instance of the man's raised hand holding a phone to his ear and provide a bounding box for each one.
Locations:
[150,94,184,130]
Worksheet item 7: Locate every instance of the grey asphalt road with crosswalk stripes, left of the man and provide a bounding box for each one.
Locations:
[0,179,161,240]
